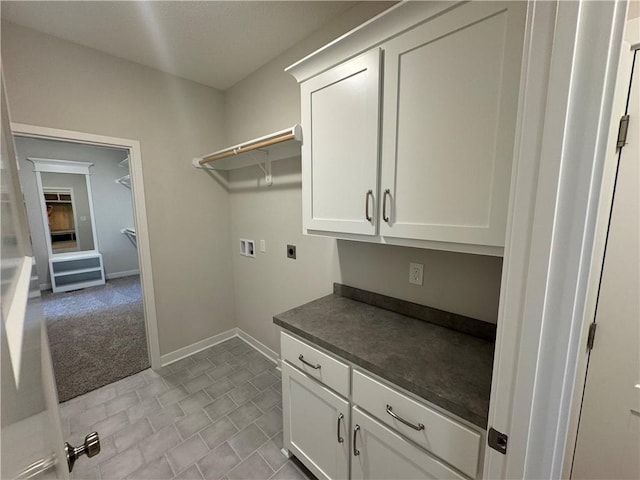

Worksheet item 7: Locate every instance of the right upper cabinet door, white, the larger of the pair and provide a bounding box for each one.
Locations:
[380,2,526,247]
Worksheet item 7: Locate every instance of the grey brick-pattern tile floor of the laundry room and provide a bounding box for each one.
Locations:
[60,337,313,480]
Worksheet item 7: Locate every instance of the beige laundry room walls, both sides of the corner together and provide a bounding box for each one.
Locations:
[2,2,502,360]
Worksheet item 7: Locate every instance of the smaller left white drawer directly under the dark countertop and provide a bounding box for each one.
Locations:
[280,333,349,397]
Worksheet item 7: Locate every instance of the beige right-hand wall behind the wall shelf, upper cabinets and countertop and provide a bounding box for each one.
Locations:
[225,2,502,352]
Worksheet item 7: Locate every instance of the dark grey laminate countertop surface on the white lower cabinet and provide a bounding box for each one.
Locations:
[273,286,494,429]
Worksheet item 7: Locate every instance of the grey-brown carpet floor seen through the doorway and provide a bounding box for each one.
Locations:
[42,276,149,402]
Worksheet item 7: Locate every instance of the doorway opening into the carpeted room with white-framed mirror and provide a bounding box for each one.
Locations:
[12,124,159,402]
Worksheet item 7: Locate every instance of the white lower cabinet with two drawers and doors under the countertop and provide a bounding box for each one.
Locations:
[281,333,484,480]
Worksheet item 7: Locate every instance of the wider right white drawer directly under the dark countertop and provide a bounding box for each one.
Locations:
[353,370,481,478]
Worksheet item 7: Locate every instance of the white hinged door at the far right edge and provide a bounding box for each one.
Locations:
[571,47,640,480]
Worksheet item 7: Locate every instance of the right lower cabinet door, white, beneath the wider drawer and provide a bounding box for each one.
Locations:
[351,407,466,480]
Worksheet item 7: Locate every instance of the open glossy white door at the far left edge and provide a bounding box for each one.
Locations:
[0,73,69,479]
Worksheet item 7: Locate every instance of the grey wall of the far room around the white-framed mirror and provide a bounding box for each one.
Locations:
[15,137,138,288]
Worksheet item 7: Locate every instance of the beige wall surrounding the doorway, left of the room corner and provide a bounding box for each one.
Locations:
[2,22,235,354]
